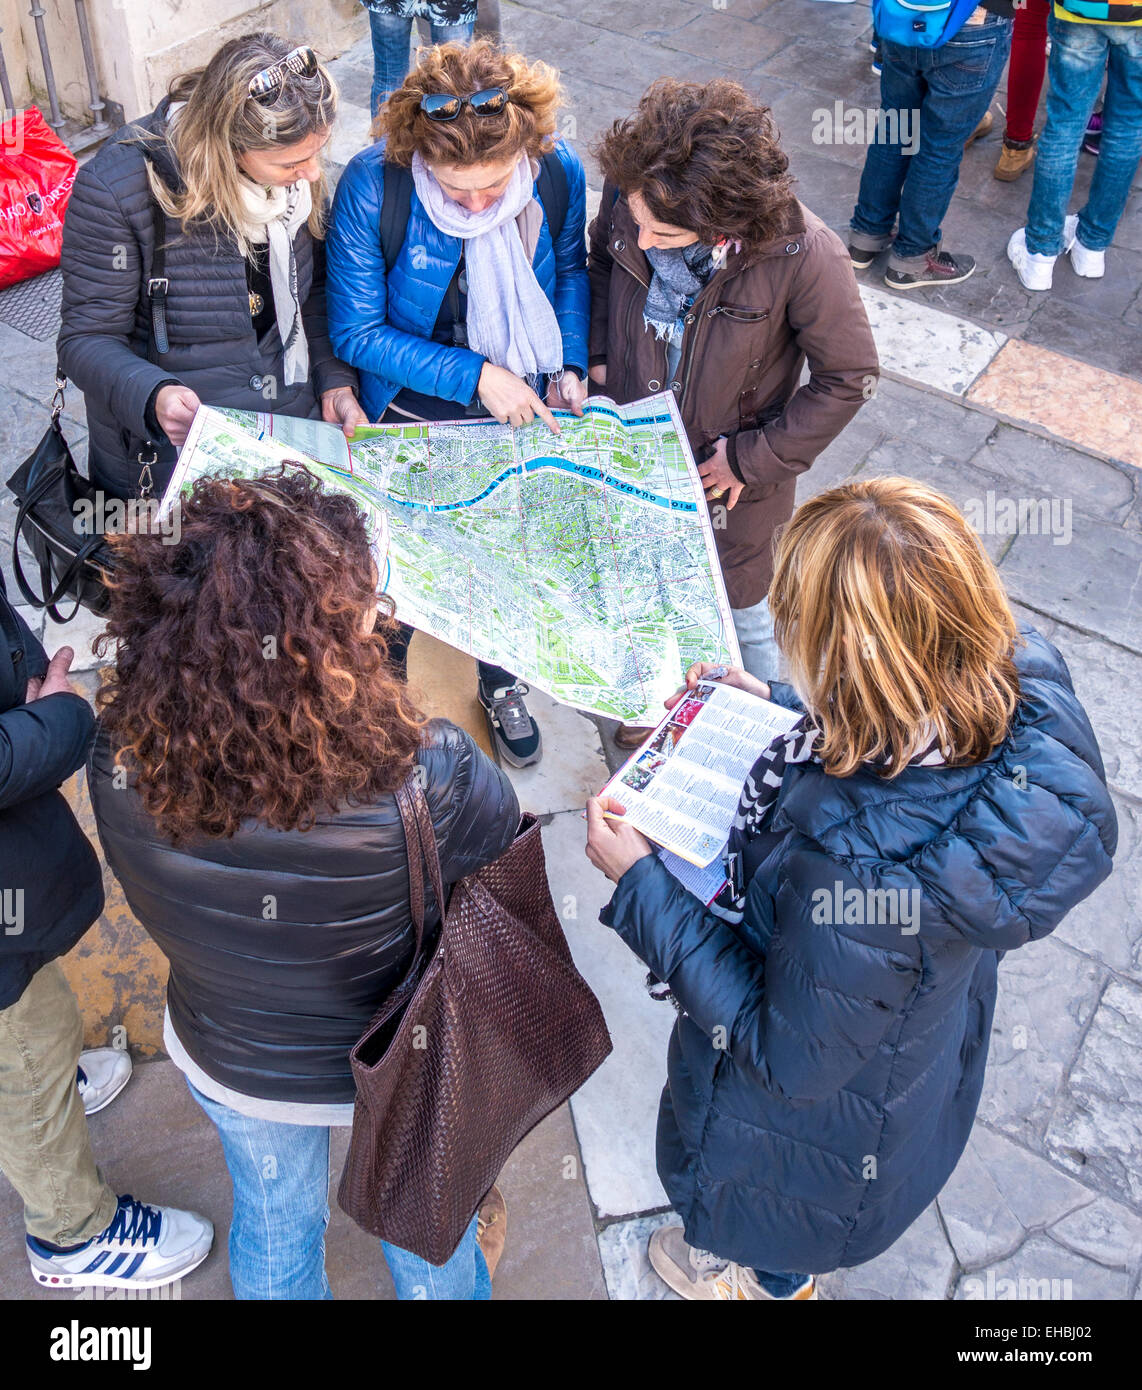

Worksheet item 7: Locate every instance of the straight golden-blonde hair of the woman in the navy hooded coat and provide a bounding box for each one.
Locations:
[770,478,1020,777]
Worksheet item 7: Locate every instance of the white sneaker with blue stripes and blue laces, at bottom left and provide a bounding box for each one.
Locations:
[28,1195,214,1289]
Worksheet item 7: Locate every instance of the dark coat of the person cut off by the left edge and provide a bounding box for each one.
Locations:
[0,594,103,1009]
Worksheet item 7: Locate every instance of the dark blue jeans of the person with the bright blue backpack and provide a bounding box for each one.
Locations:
[850,13,1011,271]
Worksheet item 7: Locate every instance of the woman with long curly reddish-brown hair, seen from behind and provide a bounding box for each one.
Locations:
[89,468,520,1298]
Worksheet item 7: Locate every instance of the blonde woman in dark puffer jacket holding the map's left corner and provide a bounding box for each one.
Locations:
[58,33,365,496]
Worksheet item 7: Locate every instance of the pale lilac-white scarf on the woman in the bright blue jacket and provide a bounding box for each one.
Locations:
[413,154,563,381]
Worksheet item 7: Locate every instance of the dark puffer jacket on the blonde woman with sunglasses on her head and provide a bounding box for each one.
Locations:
[57,97,357,496]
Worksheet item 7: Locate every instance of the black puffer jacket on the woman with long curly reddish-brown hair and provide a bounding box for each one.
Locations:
[90,720,520,1104]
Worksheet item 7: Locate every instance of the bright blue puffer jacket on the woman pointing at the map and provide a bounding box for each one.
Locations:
[325,140,589,420]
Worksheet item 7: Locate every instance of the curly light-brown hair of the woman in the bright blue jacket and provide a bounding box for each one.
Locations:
[372,39,563,167]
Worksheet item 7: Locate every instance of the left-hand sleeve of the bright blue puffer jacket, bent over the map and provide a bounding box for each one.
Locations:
[325,150,483,404]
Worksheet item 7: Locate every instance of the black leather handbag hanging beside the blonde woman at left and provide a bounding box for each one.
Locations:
[8,374,158,623]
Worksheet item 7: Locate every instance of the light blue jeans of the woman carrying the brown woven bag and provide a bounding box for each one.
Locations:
[186,1081,492,1300]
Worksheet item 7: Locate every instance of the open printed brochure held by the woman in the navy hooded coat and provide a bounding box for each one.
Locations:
[603,681,800,872]
